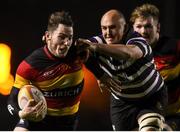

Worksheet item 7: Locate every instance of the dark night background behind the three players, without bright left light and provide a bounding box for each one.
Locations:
[0,0,180,131]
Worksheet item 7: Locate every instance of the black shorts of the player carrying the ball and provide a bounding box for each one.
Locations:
[16,114,78,131]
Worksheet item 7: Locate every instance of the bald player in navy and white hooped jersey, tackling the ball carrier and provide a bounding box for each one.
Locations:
[77,9,167,131]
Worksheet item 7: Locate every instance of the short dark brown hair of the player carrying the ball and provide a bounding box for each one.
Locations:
[47,11,73,31]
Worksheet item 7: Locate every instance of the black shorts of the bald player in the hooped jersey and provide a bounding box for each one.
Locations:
[111,86,168,131]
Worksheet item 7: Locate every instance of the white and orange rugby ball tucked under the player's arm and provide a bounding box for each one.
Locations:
[18,85,47,121]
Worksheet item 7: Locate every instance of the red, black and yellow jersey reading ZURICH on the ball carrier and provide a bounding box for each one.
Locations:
[14,46,84,116]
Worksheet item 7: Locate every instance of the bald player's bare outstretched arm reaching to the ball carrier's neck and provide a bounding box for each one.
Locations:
[76,38,143,60]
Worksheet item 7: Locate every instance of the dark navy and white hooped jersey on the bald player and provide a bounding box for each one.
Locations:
[89,32,164,99]
